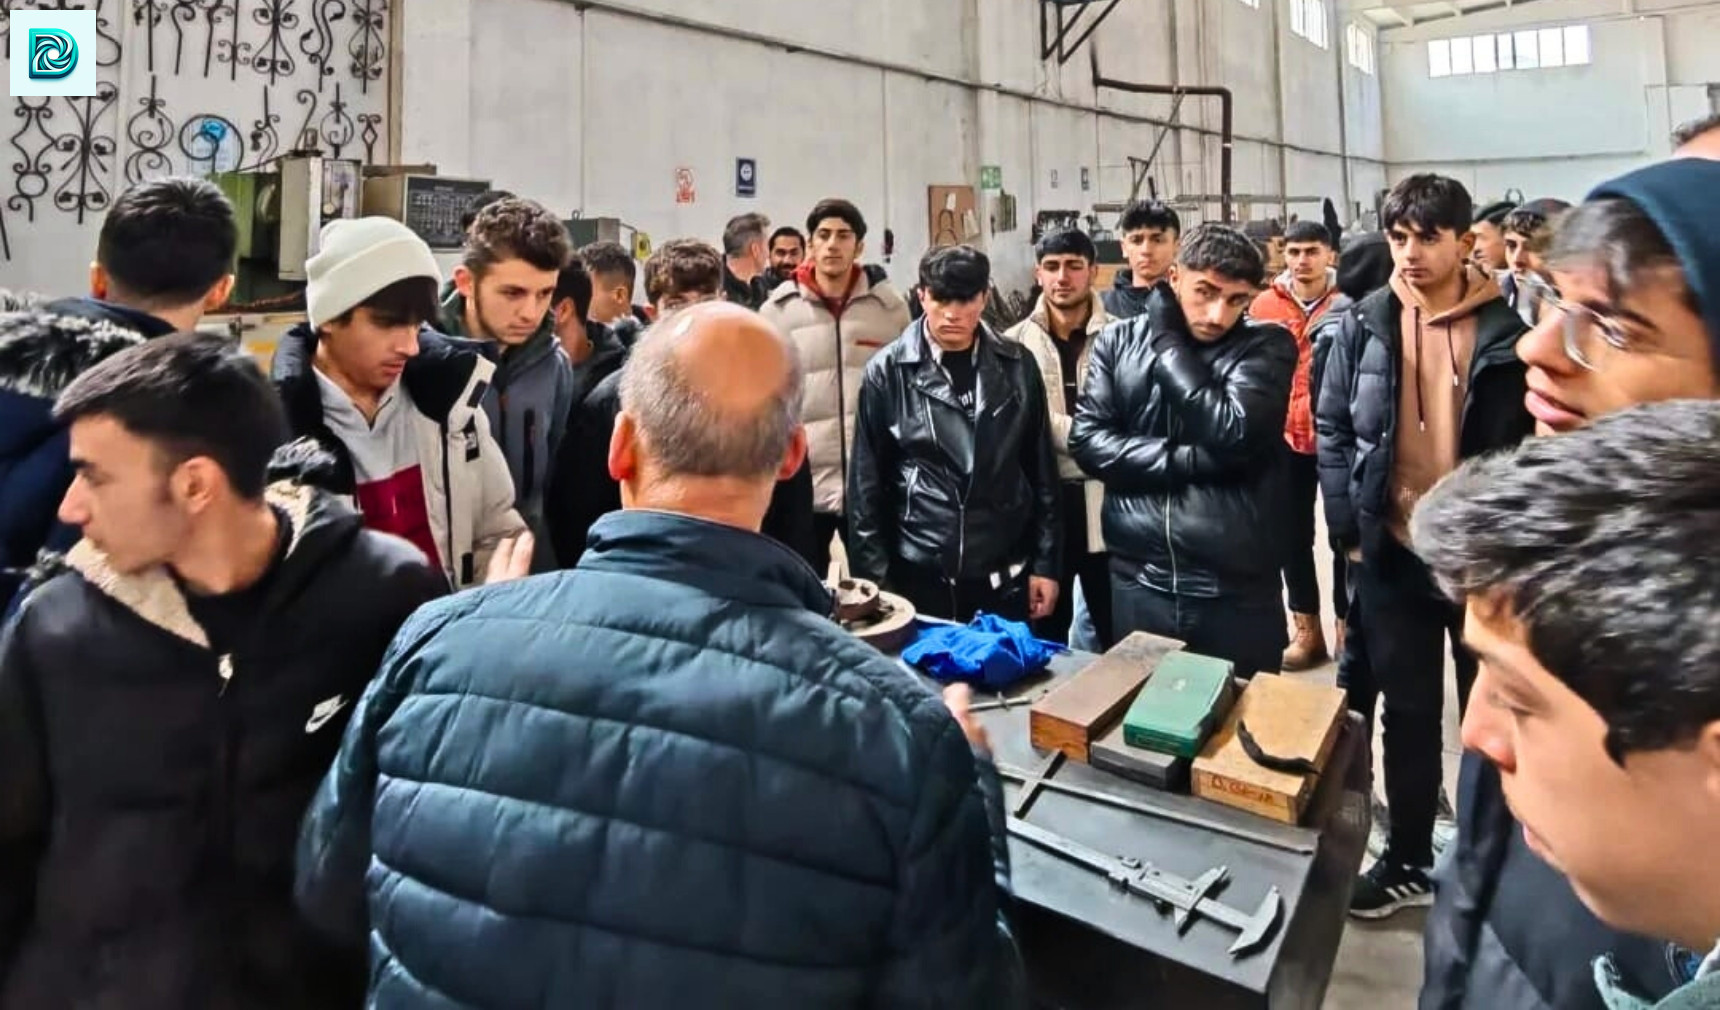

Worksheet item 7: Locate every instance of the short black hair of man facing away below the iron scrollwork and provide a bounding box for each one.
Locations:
[96,177,239,308]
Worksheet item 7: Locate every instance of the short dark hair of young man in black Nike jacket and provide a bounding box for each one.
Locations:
[53,330,287,501]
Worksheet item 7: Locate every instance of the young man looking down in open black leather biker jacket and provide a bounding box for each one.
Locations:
[846,246,1063,621]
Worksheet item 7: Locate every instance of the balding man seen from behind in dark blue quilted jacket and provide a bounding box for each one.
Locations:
[299,303,1023,1010]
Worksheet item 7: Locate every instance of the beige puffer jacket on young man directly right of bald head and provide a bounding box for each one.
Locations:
[759,270,908,513]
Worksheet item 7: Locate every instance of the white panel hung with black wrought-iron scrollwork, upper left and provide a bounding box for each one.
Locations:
[0,0,390,271]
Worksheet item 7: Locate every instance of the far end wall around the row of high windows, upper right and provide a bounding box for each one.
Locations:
[1379,0,1720,200]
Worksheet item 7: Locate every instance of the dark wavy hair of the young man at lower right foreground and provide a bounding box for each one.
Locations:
[1410,401,1720,764]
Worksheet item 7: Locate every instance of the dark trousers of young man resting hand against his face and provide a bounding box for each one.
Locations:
[1111,559,1290,676]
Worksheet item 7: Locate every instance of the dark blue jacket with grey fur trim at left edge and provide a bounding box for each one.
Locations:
[0,293,172,611]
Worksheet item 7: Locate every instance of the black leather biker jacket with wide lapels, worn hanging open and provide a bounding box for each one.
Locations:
[848,322,1063,583]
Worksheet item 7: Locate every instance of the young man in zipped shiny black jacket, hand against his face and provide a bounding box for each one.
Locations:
[1070,225,1297,676]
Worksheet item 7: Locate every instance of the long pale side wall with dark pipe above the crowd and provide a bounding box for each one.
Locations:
[397,0,1385,289]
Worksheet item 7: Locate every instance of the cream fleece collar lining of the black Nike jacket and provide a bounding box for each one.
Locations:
[65,480,363,649]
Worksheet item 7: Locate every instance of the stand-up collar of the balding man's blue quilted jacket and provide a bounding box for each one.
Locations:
[578,509,834,616]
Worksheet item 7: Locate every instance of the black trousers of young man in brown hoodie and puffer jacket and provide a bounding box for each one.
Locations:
[1338,537,1476,869]
